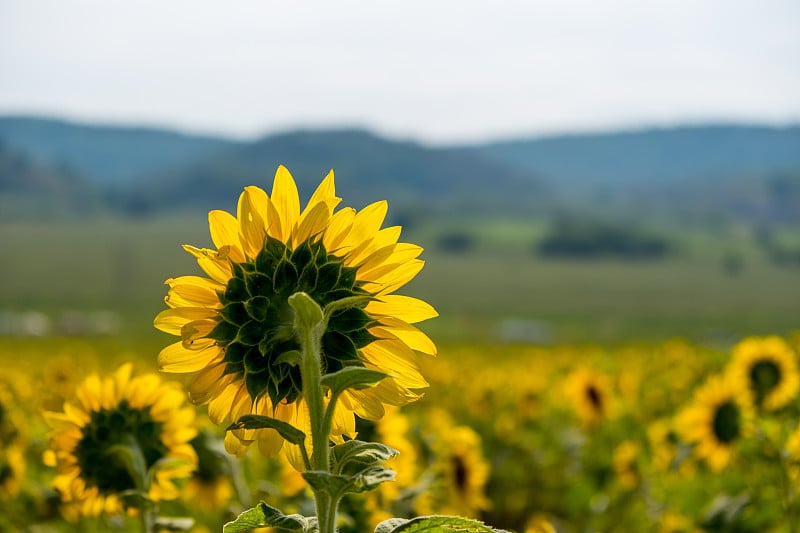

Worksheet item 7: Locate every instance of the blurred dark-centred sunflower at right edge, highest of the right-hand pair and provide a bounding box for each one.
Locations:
[728,337,800,411]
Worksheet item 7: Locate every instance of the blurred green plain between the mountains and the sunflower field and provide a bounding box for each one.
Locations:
[0,216,800,343]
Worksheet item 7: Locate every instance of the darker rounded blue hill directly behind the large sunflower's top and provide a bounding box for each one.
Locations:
[123,130,541,217]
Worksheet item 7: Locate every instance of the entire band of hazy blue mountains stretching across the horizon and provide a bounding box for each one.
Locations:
[0,116,800,222]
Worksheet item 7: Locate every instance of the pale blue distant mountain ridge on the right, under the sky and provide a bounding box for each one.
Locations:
[482,125,800,187]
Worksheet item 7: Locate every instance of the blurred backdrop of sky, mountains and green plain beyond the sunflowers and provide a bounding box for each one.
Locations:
[0,0,800,344]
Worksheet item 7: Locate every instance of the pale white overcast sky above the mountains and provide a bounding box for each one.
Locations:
[0,0,800,144]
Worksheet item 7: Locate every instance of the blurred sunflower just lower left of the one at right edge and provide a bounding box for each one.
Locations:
[675,375,753,472]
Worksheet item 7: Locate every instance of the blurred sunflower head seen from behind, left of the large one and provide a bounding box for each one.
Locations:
[45,363,197,519]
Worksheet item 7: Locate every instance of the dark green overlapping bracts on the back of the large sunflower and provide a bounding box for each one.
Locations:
[209,236,375,405]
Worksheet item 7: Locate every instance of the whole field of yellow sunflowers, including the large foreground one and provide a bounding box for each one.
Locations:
[0,168,800,533]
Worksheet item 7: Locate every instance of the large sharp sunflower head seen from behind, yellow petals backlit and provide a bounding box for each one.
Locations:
[155,166,437,466]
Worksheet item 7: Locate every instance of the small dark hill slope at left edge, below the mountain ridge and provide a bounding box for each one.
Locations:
[0,142,102,221]
